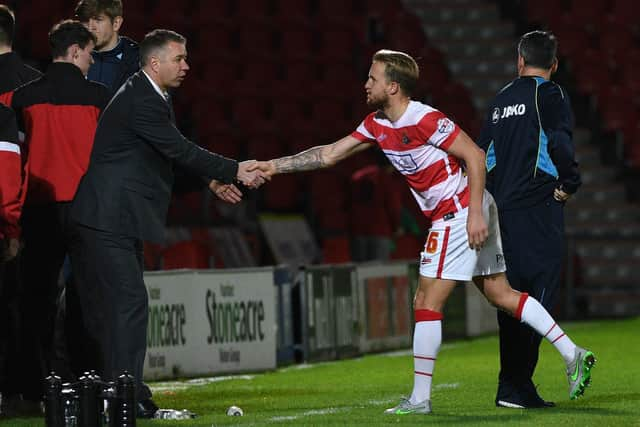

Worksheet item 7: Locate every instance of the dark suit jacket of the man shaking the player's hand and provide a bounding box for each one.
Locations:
[71,71,238,242]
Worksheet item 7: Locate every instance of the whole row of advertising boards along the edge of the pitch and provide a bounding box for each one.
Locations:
[144,261,497,380]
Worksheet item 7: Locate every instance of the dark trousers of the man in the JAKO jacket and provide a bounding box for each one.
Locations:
[498,199,564,397]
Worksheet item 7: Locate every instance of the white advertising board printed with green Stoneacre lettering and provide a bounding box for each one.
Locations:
[144,267,278,380]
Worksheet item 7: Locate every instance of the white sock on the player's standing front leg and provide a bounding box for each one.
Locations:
[409,320,442,405]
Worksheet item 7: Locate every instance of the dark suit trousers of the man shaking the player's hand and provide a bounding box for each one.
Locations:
[71,223,151,400]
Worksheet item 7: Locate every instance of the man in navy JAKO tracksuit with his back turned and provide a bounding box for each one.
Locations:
[478,31,580,408]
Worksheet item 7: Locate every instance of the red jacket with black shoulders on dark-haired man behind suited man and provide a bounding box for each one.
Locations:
[0,62,109,217]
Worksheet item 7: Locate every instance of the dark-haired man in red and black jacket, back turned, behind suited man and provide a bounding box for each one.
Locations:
[0,20,109,408]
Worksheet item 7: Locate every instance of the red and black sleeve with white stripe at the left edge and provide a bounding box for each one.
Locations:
[0,105,22,238]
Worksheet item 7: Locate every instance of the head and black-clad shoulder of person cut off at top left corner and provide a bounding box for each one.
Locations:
[0,4,42,93]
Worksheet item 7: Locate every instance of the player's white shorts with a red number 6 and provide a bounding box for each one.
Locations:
[420,190,507,281]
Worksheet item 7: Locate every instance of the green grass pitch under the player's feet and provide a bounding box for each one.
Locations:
[0,318,640,427]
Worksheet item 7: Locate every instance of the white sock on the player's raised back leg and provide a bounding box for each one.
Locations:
[520,294,576,363]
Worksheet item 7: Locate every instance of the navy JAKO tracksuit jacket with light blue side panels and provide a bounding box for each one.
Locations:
[478,77,581,211]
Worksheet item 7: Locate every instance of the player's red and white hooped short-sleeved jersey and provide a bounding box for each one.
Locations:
[351,101,469,221]
